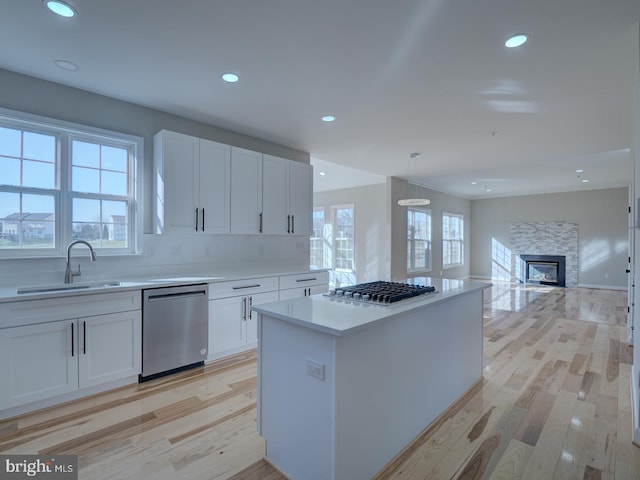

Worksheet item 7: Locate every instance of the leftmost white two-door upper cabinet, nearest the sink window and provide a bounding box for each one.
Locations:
[153,130,231,233]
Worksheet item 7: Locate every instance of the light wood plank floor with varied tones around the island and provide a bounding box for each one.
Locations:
[0,285,640,480]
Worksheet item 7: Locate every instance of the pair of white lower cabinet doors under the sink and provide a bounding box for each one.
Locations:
[0,310,142,410]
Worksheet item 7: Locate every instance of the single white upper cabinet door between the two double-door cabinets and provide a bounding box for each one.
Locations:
[231,147,262,234]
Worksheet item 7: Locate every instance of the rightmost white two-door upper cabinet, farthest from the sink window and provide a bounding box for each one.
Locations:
[262,154,313,236]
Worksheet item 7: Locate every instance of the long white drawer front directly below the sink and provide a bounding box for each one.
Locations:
[0,290,142,328]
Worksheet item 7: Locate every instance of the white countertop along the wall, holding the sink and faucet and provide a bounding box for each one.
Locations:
[0,269,326,303]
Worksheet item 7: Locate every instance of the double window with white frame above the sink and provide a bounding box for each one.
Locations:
[0,110,142,257]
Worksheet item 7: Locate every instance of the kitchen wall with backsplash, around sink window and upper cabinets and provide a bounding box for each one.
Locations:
[0,69,310,286]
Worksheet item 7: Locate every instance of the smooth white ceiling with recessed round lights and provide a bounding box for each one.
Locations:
[0,0,640,198]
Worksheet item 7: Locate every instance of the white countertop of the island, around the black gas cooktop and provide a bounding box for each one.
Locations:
[253,277,491,336]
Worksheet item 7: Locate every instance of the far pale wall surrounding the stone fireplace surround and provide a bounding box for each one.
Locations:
[471,188,629,289]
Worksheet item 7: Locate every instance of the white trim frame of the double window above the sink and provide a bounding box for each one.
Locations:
[0,107,144,259]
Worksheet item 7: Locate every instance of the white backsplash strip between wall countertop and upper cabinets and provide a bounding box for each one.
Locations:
[0,234,309,287]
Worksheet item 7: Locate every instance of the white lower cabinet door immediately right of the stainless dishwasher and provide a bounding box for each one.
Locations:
[209,297,247,355]
